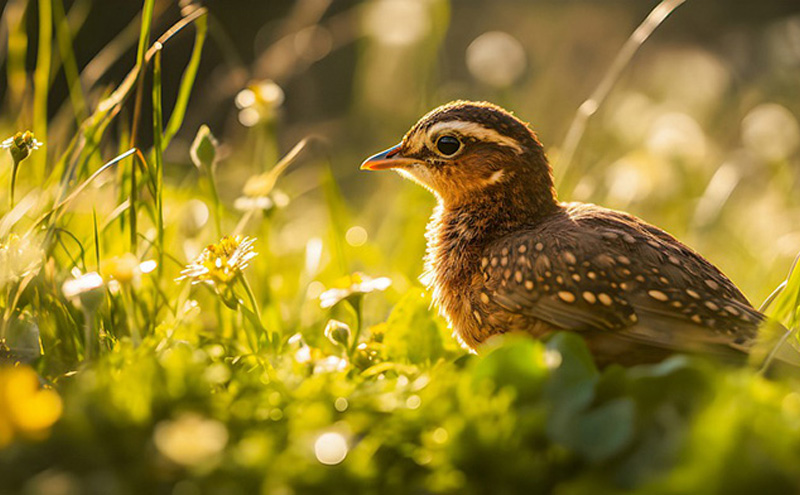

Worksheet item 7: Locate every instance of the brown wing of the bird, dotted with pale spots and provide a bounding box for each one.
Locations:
[482,205,763,356]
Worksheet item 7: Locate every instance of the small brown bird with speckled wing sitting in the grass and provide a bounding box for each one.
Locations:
[361,101,764,364]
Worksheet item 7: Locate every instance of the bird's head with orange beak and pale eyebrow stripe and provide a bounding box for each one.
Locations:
[361,101,555,207]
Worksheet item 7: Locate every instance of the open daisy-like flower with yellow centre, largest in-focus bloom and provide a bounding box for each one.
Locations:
[178,235,258,287]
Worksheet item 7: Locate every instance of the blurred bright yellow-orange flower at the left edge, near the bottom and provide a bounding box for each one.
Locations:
[0,366,62,447]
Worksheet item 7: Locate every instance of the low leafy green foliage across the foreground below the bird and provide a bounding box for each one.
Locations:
[0,330,800,493]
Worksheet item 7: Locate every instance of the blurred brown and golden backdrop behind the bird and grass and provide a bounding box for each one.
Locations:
[6,0,800,304]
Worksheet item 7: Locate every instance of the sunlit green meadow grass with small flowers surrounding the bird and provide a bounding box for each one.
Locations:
[0,0,800,494]
